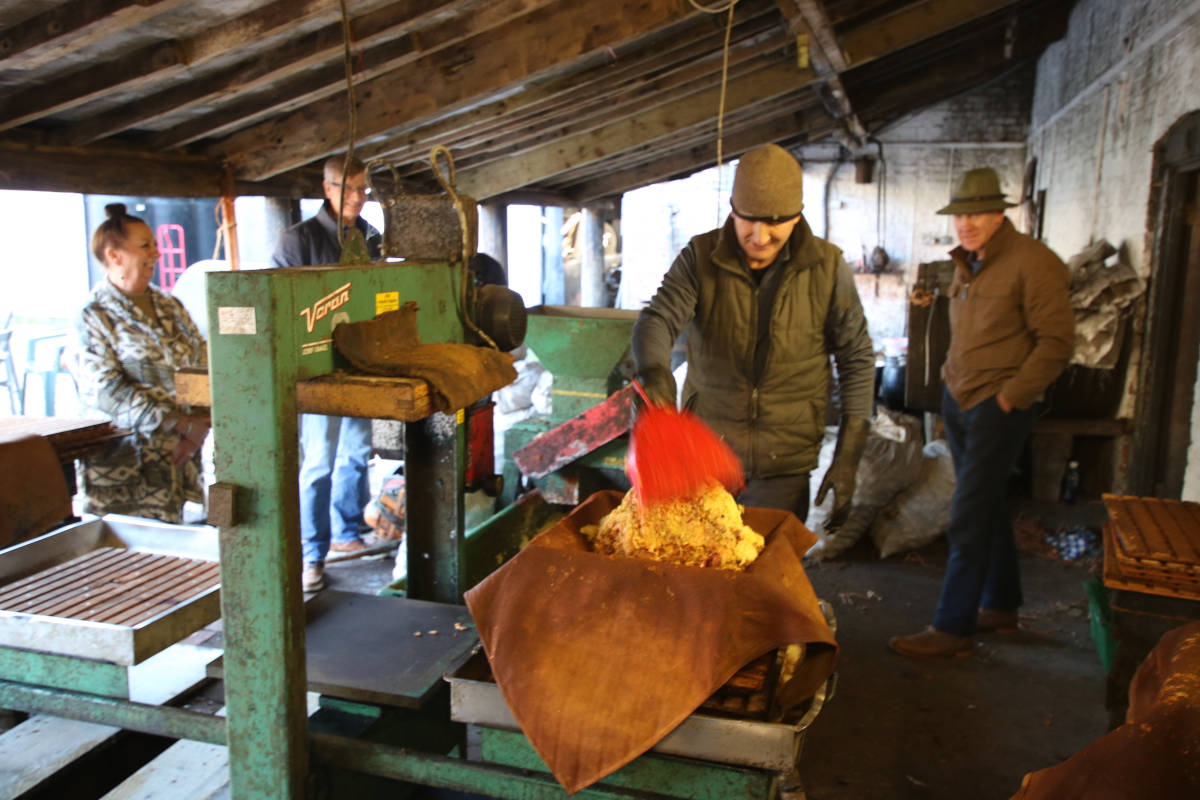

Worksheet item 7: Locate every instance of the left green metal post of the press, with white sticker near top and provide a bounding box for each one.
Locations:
[208,272,308,800]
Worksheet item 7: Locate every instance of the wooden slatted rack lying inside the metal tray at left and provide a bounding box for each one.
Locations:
[0,547,221,627]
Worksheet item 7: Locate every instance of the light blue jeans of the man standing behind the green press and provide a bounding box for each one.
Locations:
[300,414,371,564]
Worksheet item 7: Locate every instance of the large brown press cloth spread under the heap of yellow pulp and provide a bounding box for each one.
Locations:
[466,492,838,793]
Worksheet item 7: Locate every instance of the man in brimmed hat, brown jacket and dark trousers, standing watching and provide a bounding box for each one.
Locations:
[889,168,1075,657]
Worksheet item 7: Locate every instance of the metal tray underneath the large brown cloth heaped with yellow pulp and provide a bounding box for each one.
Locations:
[445,652,834,772]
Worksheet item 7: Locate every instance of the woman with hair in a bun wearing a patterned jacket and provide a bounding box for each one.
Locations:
[76,203,209,523]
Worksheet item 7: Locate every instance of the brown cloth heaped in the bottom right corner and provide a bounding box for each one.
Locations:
[1013,622,1200,800]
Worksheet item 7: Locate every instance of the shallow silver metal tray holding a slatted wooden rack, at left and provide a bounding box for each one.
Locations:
[0,515,221,666]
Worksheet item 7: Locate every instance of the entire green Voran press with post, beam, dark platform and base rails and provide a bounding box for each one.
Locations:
[0,261,826,800]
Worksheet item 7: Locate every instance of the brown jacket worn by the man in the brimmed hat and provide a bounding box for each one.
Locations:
[942,219,1075,410]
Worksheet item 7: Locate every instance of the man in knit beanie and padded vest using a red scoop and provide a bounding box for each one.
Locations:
[632,145,875,529]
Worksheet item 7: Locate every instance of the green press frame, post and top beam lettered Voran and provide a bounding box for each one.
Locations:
[208,263,463,800]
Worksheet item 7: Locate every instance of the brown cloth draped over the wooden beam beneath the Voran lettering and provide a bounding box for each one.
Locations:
[334,302,517,411]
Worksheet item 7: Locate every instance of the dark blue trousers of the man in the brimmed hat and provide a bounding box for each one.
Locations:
[934,390,1039,636]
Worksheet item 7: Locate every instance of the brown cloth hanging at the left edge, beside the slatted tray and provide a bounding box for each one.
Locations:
[0,437,72,547]
